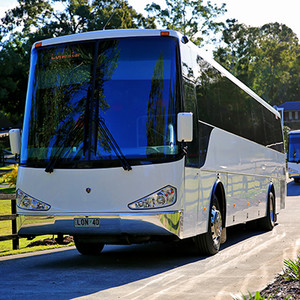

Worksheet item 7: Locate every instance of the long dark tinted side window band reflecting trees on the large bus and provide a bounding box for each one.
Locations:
[196,57,284,152]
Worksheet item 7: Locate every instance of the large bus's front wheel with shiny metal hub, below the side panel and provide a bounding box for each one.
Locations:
[194,195,222,255]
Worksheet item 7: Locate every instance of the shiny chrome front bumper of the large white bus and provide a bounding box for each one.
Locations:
[18,211,183,239]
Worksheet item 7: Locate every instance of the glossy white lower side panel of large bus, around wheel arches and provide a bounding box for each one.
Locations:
[185,128,285,234]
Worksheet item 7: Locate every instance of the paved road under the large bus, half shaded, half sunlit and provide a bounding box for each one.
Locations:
[0,182,300,300]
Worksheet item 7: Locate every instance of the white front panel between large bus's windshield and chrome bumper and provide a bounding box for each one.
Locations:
[17,160,184,214]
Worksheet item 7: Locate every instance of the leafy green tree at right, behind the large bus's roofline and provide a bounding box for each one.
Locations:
[215,20,300,105]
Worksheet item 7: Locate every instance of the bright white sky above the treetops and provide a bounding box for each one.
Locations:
[0,0,300,40]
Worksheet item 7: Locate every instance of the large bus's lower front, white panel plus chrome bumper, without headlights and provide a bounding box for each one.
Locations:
[17,159,192,238]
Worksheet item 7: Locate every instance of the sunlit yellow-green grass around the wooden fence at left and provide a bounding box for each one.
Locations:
[0,166,73,256]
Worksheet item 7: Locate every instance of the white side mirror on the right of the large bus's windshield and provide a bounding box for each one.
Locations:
[177,112,193,142]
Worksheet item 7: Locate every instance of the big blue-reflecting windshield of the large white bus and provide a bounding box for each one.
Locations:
[21,37,180,168]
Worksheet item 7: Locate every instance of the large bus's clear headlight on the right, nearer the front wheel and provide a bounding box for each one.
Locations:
[128,185,177,209]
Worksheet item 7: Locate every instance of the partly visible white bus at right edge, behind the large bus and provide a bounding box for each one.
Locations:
[287,130,300,183]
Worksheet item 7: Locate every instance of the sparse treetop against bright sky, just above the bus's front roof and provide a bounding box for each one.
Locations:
[145,0,226,45]
